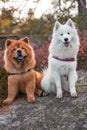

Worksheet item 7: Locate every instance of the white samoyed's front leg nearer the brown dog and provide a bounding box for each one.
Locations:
[53,72,63,98]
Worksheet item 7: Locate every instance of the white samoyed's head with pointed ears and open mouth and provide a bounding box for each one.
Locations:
[53,19,77,47]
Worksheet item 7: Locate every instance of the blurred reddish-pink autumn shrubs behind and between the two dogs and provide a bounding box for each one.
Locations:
[0,31,87,71]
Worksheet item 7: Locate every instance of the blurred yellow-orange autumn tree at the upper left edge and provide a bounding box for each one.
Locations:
[0,8,17,33]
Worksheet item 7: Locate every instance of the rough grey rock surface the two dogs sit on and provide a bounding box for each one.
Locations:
[0,86,87,130]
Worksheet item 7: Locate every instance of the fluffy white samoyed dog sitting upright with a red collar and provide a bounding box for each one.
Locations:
[41,19,80,98]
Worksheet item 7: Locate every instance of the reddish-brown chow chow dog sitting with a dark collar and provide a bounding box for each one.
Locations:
[3,37,43,104]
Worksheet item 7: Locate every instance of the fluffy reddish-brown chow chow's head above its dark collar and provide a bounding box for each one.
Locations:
[4,37,36,72]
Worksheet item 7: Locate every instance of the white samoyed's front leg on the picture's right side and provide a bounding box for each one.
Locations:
[69,71,77,97]
